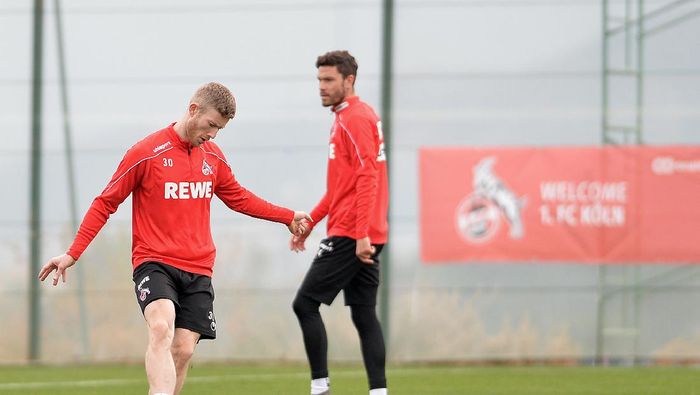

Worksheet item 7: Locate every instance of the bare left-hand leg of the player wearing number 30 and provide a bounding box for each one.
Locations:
[143,299,176,395]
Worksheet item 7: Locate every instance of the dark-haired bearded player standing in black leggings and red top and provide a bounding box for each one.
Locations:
[290,51,389,395]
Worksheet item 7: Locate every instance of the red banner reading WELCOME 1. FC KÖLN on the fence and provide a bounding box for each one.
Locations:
[420,146,700,263]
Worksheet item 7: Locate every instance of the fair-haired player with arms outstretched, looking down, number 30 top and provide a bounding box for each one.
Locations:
[39,82,310,395]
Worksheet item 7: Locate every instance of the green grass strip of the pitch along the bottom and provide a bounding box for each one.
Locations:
[0,364,700,395]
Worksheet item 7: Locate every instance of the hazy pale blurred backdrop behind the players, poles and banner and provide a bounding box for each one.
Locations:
[0,0,700,363]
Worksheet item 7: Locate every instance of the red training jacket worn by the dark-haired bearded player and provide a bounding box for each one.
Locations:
[310,96,389,244]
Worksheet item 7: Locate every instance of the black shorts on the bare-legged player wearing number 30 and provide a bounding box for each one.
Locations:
[134,262,216,339]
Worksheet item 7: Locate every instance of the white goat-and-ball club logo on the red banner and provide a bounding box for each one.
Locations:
[455,156,525,244]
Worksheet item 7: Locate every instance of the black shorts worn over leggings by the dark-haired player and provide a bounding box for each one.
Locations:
[299,236,384,306]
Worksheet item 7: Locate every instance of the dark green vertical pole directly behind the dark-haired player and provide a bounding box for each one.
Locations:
[380,0,394,350]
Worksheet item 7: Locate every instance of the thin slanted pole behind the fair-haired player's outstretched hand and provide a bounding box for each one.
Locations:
[54,0,90,358]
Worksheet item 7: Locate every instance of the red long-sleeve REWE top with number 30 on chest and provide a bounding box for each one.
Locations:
[68,124,294,276]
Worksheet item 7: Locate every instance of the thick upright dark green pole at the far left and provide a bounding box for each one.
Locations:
[28,0,44,362]
